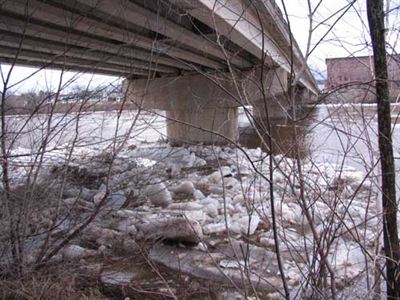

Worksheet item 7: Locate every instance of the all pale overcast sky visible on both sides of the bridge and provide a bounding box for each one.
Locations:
[0,0,400,93]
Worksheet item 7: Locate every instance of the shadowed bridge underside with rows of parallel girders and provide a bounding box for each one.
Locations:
[0,0,259,78]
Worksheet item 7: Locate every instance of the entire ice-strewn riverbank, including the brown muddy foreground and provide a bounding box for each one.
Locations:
[1,144,378,299]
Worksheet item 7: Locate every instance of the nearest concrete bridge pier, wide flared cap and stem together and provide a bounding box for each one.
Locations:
[124,74,239,145]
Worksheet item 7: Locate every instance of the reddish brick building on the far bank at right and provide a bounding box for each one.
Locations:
[325,55,400,90]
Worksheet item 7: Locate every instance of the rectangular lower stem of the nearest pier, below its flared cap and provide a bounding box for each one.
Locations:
[167,107,239,145]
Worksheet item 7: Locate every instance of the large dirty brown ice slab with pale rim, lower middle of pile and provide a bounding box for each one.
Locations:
[136,216,203,243]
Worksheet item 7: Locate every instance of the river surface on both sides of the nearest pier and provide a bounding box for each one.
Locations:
[7,104,400,190]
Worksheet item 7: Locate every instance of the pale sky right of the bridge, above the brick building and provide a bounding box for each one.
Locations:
[282,0,400,70]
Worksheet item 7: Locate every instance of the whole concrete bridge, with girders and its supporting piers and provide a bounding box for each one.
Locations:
[0,0,318,143]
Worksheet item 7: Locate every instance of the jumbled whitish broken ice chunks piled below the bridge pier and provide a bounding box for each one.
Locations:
[1,137,378,298]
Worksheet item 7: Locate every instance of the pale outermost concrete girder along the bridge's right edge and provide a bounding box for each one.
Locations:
[181,0,318,94]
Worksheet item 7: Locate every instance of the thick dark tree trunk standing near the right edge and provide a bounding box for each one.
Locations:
[367,0,400,299]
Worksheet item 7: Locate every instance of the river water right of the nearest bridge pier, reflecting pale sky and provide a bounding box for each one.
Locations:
[240,104,400,190]
